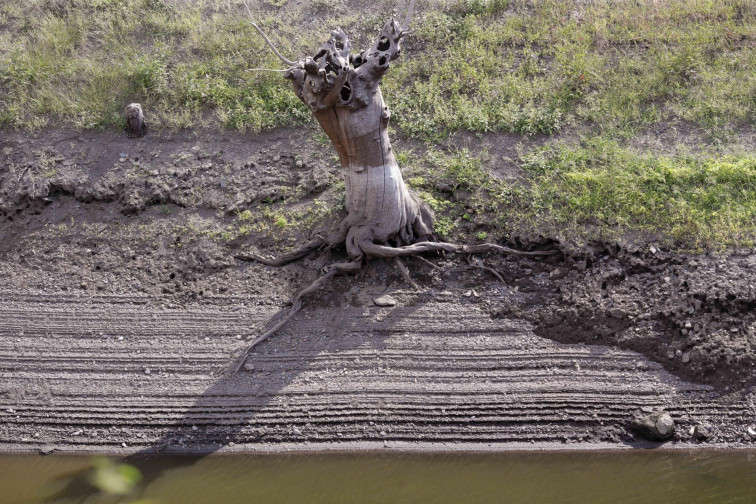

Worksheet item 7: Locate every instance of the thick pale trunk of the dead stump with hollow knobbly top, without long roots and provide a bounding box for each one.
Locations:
[285,20,433,260]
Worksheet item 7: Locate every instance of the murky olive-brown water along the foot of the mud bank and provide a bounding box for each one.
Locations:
[0,451,756,504]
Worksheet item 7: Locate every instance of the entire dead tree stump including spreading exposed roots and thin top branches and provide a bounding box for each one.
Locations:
[229,0,557,372]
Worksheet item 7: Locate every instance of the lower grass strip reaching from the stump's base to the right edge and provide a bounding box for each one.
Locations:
[398,142,756,250]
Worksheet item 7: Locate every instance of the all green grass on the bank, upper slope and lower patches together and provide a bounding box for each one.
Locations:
[0,0,756,248]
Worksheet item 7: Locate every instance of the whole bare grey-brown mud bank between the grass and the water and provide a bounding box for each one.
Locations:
[0,130,756,452]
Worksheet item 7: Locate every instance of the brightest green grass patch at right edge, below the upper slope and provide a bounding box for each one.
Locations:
[521,139,756,248]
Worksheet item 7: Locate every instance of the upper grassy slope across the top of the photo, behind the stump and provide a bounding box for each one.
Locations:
[0,0,756,138]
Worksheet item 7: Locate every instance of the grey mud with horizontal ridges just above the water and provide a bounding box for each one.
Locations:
[0,292,753,451]
